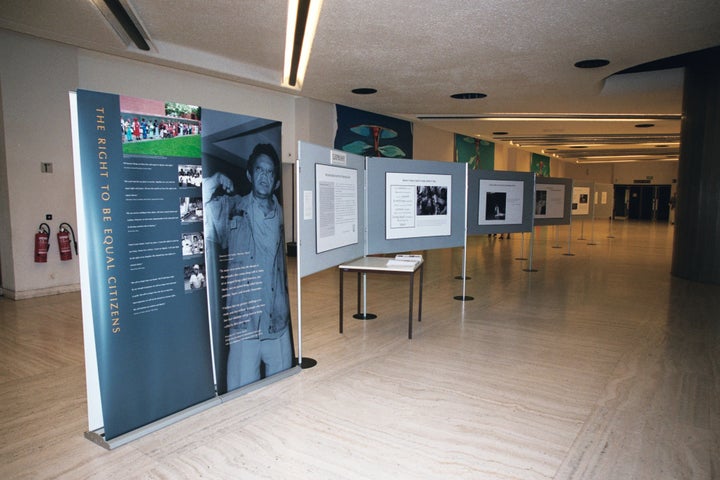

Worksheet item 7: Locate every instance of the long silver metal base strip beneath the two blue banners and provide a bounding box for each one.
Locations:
[85,366,300,450]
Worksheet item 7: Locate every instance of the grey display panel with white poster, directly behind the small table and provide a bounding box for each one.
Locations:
[367,157,467,254]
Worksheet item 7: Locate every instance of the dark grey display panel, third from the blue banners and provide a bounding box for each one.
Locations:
[467,170,535,235]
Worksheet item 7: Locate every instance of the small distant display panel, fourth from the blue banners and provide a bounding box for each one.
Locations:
[533,177,573,225]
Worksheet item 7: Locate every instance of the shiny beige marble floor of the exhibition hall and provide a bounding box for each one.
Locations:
[0,221,720,480]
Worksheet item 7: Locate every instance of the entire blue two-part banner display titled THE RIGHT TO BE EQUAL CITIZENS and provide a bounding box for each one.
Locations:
[76,90,293,440]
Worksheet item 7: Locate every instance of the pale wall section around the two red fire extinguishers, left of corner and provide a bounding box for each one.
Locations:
[0,30,79,298]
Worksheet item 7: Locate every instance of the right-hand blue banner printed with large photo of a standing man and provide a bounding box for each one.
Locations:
[202,109,294,394]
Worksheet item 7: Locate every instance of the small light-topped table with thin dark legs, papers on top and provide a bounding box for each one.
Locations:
[338,257,423,339]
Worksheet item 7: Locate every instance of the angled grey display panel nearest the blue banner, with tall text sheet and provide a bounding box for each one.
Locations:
[297,142,366,278]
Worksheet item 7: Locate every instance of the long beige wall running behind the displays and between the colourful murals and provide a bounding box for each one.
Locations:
[0,29,677,298]
